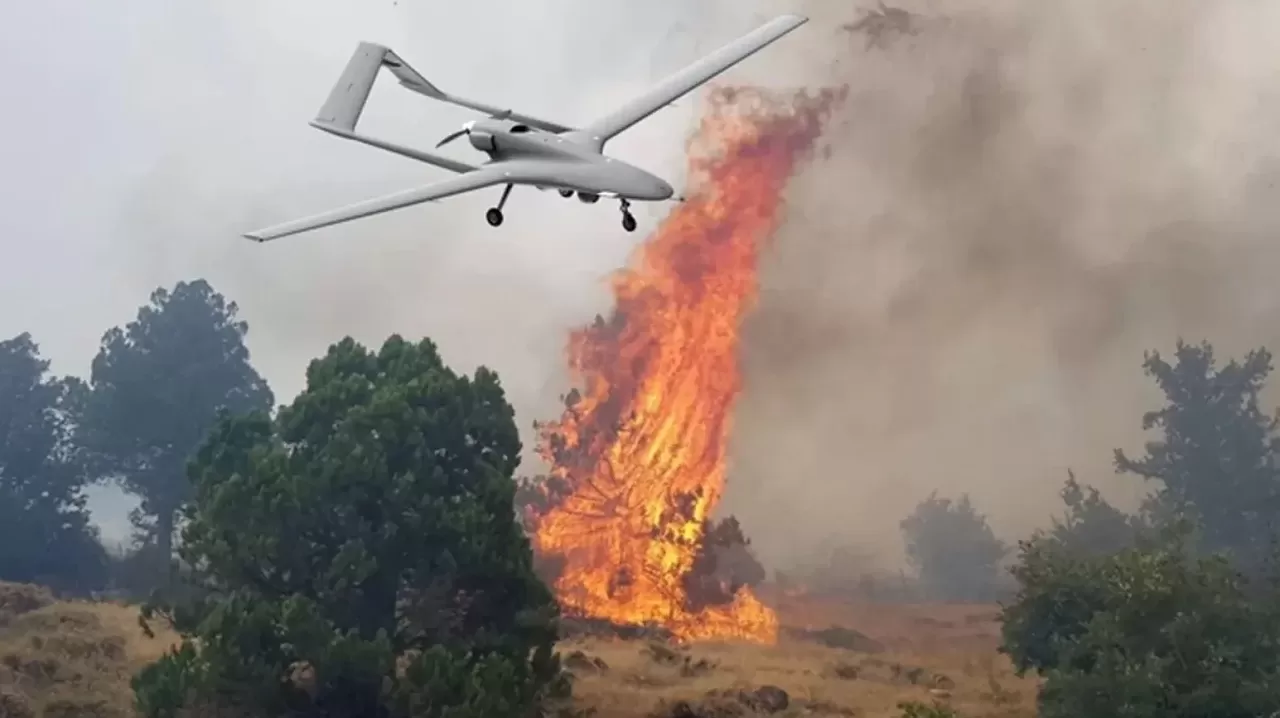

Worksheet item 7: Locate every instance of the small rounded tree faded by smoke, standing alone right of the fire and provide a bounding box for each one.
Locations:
[900,491,1009,600]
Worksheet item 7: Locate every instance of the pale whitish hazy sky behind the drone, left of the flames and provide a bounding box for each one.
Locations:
[0,0,788,536]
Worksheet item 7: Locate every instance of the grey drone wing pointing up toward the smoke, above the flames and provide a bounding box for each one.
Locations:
[580,15,809,147]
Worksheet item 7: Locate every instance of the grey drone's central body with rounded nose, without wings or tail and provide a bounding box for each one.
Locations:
[468,119,675,202]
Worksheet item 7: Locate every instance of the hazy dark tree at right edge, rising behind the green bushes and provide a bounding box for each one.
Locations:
[1115,342,1280,575]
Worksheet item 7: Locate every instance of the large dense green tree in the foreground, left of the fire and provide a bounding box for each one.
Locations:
[134,337,567,718]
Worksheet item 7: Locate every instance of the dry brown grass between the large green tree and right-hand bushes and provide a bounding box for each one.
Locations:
[563,605,1036,718]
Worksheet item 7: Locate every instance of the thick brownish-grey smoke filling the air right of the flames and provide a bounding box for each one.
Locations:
[723,0,1280,567]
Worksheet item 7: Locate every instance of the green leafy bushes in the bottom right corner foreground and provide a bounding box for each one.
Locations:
[1002,519,1280,718]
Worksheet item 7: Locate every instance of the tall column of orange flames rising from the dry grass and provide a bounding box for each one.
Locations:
[534,88,837,642]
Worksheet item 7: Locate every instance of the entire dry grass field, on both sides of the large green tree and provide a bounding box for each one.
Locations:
[0,586,1036,718]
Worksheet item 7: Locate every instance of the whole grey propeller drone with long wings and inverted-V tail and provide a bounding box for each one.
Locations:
[244,14,808,242]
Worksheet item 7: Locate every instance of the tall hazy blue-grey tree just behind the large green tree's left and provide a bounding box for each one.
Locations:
[81,279,274,561]
